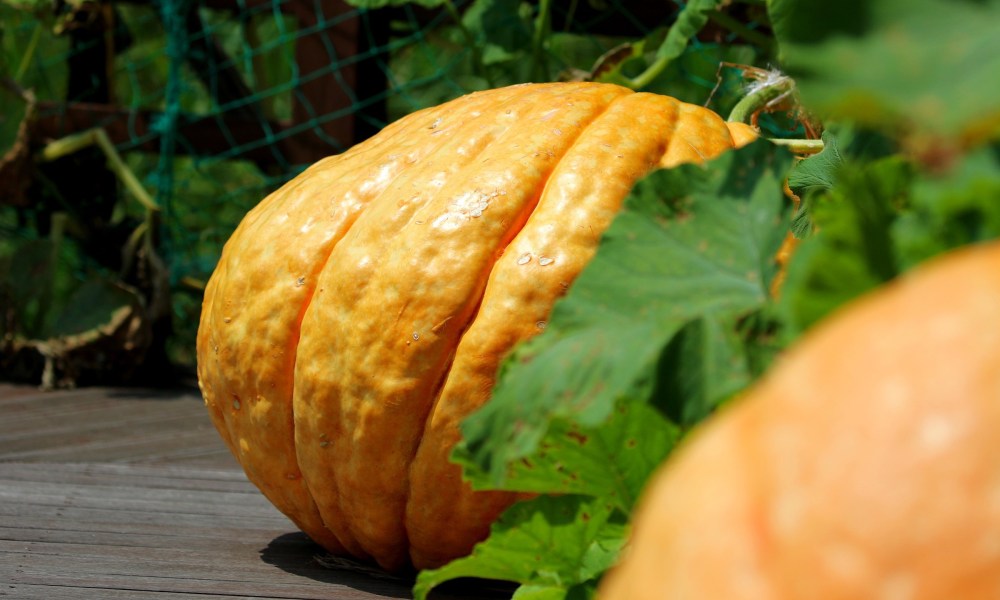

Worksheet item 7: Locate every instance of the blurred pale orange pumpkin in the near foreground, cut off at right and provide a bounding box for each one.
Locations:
[598,242,1000,600]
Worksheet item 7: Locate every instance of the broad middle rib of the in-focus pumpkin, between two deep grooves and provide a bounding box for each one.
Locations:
[296,86,625,569]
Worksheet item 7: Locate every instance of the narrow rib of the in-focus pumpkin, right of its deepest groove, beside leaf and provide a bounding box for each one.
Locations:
[407,89,696,568]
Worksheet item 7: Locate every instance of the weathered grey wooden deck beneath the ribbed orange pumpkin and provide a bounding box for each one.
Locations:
[0,383,511,600]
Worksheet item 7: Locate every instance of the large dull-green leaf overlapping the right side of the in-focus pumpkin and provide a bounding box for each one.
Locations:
[456,142,791,491]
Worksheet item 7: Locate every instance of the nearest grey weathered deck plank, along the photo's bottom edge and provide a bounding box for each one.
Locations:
[0,463,503,600]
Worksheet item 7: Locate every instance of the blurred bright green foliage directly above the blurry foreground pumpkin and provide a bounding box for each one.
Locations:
[779,142,1000,337]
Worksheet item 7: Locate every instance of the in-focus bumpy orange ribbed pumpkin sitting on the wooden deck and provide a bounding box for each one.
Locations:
[198,83,753,570]
